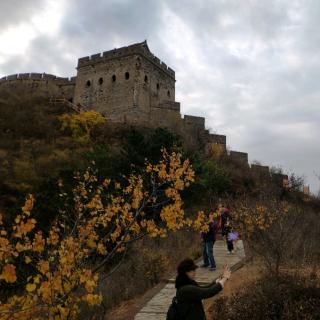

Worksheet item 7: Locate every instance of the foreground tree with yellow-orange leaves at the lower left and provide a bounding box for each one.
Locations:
[0,150,194,320]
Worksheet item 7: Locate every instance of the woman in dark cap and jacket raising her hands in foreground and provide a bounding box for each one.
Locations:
[176,259,231,320]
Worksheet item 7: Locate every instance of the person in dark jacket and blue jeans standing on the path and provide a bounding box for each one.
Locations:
[201,215,217,271]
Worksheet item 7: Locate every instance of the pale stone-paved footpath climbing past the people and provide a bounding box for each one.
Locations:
[134,240,245,320]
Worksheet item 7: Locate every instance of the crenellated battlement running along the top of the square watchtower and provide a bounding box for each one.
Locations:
[78,41,175,78]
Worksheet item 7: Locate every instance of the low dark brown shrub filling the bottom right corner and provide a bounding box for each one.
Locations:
[209,273,320,320]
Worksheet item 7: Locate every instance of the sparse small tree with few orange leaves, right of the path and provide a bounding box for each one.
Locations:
[230,199,303,275]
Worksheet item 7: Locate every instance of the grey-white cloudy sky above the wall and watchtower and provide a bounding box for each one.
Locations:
[0,0,320,192]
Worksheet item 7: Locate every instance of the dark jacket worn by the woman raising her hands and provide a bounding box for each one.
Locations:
[176,281,222,320]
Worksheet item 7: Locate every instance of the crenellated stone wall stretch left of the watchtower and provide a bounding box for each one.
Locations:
[0,73,76,100]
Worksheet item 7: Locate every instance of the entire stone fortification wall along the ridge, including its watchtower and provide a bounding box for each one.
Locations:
[0,42,280,181]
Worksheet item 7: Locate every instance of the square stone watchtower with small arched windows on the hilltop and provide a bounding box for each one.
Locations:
[74,41,180,125]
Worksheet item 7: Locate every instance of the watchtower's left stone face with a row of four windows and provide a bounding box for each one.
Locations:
[74,56,141,122]
